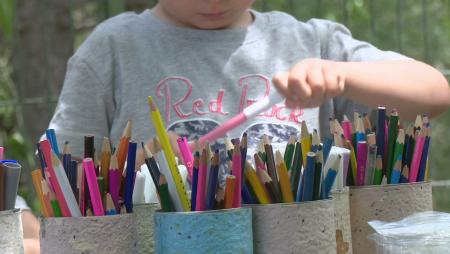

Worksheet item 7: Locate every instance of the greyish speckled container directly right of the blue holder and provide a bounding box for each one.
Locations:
[249,200,336,254]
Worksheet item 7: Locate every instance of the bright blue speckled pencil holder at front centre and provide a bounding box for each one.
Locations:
[155,208,253,254]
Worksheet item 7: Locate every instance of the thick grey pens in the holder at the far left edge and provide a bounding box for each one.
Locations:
[0,146,21,211]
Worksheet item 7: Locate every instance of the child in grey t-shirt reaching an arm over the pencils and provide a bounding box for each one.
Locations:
[46,0,450,159]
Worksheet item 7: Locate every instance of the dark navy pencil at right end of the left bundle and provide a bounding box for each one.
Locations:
[124,141,137,213]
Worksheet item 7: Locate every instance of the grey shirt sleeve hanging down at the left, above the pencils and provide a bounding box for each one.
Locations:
[46,56,114,156]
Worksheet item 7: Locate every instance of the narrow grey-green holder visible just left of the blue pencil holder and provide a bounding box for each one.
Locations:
[133,203,160,254]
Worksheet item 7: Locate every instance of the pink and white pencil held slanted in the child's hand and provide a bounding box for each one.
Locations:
[190,92,284,151]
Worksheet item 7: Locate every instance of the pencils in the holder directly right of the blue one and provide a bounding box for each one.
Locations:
[234,122,348,204]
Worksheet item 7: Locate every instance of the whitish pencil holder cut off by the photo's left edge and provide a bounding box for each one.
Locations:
[0,209,24,254]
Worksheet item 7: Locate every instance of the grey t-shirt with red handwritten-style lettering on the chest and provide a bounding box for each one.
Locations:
[50,10,405,155]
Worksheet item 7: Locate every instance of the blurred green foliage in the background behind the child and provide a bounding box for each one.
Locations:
[0,0,450,211]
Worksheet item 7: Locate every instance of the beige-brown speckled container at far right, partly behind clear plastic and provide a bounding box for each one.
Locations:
[349,182,433,254]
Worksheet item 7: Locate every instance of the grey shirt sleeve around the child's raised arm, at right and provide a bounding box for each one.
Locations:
[308,19,410,123]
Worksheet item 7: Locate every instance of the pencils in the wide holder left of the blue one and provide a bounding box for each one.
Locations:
[31,122,143,217]
